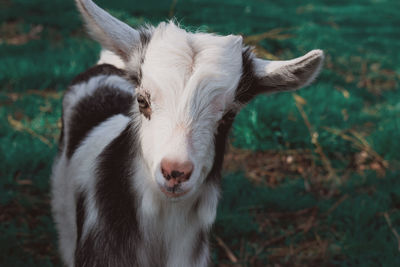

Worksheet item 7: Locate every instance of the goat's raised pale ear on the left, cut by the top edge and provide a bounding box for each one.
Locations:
[76,0,140,61]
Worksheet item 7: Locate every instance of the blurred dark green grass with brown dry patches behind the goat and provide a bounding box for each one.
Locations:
[0,0,400,266]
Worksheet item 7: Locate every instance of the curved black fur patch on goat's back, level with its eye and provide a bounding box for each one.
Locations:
[67,86,134,158]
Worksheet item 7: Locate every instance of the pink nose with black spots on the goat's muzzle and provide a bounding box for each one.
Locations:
[161,159,193,186]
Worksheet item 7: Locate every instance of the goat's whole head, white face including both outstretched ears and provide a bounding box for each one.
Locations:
[77,0,323,199]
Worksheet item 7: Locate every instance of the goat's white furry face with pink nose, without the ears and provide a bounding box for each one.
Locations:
[137,23,242,200]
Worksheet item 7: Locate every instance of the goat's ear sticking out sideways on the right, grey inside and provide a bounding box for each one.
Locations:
[253,50,324,94]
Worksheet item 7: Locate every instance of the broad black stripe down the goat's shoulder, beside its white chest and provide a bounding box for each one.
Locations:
[75,125,141,267]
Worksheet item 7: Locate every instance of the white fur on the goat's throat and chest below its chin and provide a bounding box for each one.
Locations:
[135,152,219,267]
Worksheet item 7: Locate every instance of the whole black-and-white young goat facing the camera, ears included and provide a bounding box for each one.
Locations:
[52,0,323,267]
